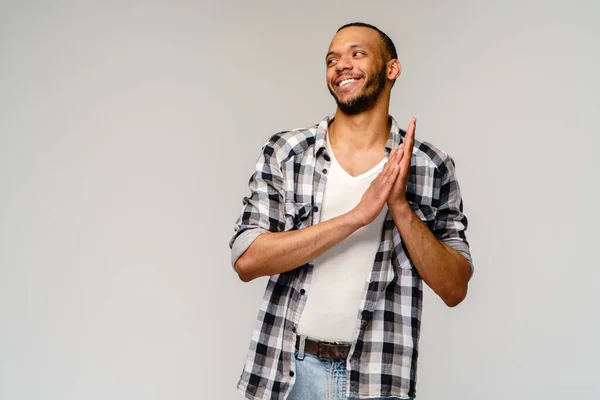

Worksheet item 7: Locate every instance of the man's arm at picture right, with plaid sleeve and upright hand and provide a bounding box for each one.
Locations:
[388,119,472,307]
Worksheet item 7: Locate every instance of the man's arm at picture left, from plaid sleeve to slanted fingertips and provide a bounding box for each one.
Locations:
[231,142,402,282]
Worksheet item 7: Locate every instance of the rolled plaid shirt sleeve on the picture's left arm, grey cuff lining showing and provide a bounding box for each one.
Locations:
[229,141,285,266]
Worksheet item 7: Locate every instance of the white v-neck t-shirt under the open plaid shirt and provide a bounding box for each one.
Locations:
[297,136,387,342]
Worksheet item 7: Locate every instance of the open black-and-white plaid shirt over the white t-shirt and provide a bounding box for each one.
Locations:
[230,116,472,400]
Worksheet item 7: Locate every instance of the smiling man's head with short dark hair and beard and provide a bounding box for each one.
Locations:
[325,22,401,115]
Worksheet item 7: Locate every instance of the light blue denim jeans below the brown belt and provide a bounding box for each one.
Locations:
[288,338,410,400]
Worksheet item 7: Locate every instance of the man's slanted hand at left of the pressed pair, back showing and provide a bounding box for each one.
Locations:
[351,147,405,226]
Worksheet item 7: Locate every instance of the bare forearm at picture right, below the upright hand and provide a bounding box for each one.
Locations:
[390,202,471,307]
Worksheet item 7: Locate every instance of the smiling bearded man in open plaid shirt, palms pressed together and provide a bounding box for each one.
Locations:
[230,23,472,400]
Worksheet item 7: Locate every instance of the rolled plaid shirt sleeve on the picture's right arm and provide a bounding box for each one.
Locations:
[433,155,474,273]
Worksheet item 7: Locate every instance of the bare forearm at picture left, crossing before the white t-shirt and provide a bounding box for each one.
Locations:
[235,212,361,282]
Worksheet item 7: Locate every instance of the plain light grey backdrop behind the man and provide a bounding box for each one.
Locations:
[0,0,600,400]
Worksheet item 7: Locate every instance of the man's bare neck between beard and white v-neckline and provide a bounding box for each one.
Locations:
[329,96,391,151]
